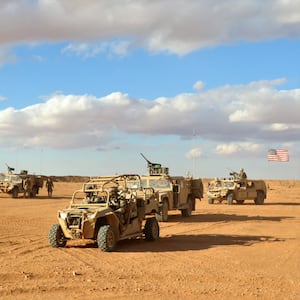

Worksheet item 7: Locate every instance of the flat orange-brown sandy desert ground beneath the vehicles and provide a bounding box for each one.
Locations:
[0,180,300,299]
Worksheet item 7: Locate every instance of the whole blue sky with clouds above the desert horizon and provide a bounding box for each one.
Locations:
[0,0,300,179]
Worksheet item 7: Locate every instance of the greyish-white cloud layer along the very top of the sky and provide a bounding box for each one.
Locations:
[0,0,300,55]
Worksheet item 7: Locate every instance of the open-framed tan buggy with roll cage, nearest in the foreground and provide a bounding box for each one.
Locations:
[49,174,159,252]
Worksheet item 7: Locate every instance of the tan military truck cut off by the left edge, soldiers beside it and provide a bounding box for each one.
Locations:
[0,167,44,198]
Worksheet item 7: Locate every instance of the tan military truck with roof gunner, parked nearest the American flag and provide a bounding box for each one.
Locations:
[207,172,267,205]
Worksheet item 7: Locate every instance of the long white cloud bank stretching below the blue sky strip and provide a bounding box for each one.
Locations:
[0,80,300,154]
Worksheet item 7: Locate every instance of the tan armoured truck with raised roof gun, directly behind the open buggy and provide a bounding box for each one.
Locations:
[141,153,203,222]
